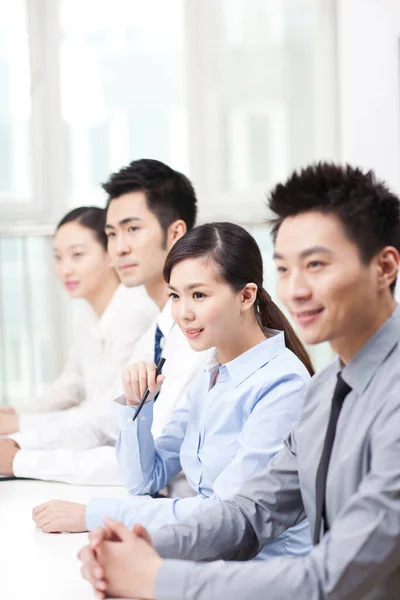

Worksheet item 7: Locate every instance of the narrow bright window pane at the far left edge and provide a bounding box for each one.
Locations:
[0,0,31,202]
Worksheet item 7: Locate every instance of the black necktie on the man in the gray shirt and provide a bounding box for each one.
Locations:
[314,373,351,544]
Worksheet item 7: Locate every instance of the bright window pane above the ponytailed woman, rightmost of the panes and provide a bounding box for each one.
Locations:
[218,0,319,193]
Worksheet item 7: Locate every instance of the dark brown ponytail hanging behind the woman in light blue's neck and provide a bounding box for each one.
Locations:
[255,288,314,376]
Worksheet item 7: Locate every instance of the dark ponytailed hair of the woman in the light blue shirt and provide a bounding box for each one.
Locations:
[163,223,314,375]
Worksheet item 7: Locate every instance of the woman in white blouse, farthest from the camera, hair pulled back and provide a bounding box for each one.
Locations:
[0,207,157,440]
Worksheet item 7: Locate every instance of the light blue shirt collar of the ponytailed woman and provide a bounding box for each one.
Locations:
[205,328,286,387]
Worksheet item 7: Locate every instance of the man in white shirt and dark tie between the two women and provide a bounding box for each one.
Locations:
[0,159,203,492]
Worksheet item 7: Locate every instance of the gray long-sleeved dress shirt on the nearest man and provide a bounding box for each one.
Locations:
[153,306,400,600]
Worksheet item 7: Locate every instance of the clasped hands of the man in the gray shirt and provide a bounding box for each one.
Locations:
[78,518,162,600]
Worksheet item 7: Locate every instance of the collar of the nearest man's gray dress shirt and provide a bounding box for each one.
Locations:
[337,305,400,395]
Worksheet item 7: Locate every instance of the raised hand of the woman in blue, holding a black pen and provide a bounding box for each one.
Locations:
[122,362,165,406]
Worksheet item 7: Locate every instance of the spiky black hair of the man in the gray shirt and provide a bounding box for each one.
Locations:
[268,162,400,291]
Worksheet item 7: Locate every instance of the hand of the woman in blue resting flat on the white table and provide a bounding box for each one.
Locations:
[32,500,87,533]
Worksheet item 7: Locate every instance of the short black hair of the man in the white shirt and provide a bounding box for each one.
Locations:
[103,158,197,235]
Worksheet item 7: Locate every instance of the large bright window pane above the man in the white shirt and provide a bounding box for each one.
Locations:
[60,0,188,205]
